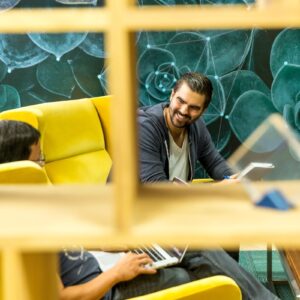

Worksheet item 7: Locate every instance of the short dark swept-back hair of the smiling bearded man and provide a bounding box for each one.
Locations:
[173,72,213,108]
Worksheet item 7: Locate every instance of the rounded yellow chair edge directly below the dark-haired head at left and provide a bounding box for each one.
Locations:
[0,160,49,184]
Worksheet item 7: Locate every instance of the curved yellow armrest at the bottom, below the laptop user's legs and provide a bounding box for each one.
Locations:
[130,276,242,300]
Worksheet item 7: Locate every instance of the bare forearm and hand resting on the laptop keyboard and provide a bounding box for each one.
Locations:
[59,253,156,300]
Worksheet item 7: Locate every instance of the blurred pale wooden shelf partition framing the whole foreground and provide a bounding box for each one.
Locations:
[0,0,300,300]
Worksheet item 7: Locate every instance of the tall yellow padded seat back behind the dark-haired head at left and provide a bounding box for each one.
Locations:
[0,96,112,184]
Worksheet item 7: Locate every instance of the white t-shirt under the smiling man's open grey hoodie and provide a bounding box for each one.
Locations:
[169,132,189,181]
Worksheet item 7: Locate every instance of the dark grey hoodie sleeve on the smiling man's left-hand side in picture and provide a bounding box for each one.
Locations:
[139,120,168,183]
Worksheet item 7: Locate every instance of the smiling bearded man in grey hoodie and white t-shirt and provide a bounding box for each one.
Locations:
[138,73,232,182]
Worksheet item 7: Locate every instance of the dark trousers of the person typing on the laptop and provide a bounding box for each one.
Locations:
[113,249,279,300]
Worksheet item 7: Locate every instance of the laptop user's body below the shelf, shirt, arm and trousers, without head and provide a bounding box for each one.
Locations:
[60,249,279,300]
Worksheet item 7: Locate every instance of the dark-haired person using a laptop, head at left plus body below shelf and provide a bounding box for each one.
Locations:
[0,120,278,300]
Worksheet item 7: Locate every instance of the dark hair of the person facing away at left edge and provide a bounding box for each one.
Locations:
[0,120,40,163]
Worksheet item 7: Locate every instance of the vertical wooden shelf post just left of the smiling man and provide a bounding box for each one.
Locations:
[106,0,139,232]
